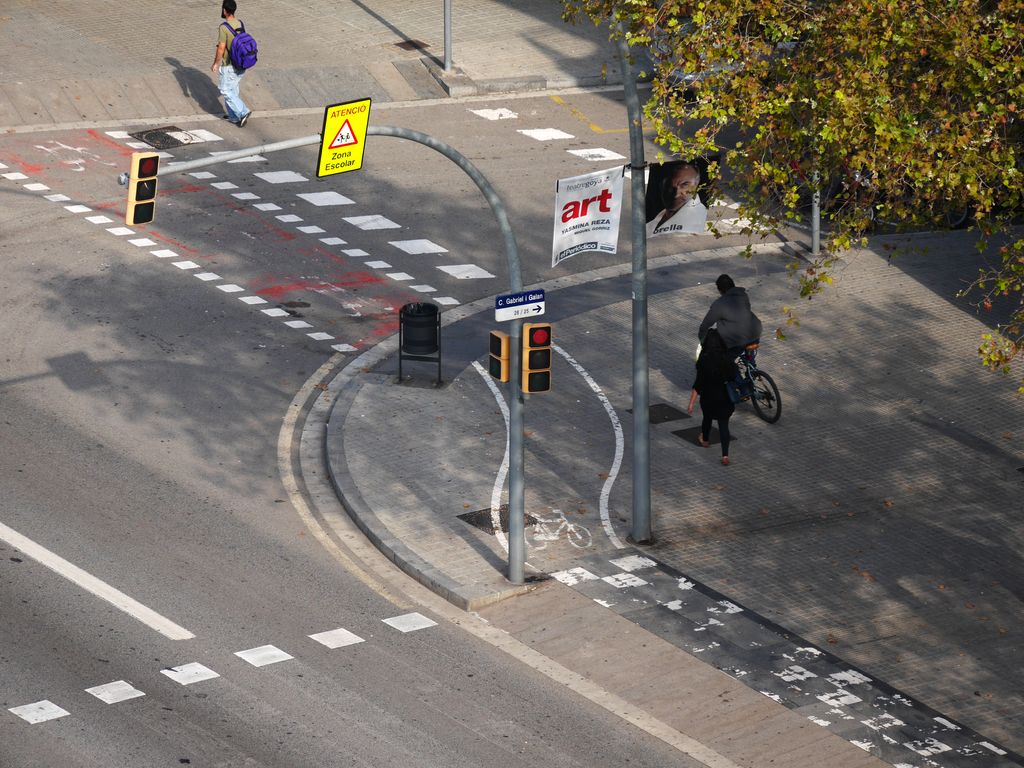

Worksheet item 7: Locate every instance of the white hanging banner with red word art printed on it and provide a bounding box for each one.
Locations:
[551,166,626,267]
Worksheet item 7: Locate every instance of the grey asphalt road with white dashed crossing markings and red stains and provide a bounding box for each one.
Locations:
[0,93,729,768]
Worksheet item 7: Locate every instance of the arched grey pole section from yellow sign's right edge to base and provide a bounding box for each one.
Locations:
[367,125,526,584]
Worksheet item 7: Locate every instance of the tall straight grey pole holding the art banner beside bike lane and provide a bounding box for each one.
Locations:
[617,29,652,544]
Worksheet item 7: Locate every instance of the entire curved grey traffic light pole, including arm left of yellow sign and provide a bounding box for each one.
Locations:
[118,125,526,584]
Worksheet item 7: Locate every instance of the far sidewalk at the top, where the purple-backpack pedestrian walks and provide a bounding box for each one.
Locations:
[0,0,621,131]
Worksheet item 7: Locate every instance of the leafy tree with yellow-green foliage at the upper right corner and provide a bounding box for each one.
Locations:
[563,0,1024,392]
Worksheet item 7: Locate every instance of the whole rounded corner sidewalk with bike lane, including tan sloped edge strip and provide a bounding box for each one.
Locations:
[326,240,1024,766]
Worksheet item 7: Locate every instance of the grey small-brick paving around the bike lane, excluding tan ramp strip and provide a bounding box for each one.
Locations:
[329,236,1024,766]
